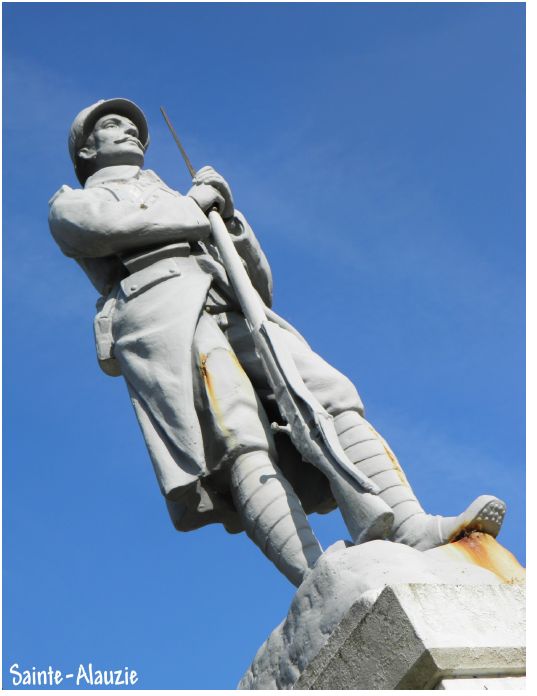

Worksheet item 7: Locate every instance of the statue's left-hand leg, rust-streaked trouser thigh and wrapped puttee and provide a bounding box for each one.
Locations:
[193,314,322,586]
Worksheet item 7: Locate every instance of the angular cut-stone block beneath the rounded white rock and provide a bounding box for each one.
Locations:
[293,585,526,689]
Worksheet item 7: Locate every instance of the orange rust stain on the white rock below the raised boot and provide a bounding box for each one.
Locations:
[448,532,526,583]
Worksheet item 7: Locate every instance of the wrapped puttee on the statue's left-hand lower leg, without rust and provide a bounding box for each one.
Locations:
[231,451,322,587]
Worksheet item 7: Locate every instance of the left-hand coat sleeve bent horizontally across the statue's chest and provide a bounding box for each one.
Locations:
[49,186,210,258]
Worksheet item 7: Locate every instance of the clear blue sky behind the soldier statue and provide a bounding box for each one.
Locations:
[3,3,525,689]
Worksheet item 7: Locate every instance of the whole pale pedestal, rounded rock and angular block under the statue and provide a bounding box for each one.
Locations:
[239,534,525,690]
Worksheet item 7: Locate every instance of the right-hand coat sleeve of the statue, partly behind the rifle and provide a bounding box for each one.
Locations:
[226,210,272,307]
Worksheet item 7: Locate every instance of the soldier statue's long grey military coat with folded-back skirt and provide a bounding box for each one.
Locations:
[49,165,331,531]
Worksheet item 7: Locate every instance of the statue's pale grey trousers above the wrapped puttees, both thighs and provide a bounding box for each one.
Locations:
[193,312,363,467]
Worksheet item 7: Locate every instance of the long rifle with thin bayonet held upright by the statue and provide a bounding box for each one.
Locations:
[160,107,393,543]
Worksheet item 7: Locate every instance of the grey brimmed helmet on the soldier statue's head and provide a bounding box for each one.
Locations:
[68,97,149,185]
